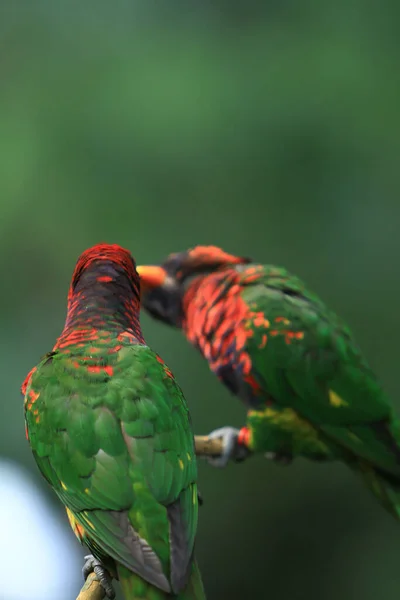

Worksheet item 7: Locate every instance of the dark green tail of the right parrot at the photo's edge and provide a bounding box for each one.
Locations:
[353,461,400,520]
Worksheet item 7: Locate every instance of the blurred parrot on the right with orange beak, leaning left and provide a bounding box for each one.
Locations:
[137,246,400,518]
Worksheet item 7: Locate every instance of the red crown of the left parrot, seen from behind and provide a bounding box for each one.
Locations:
[68,244,140,300]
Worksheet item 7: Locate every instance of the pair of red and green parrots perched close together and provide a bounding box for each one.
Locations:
[22,244,400,600]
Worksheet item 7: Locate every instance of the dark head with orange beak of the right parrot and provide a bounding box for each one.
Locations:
[137,246,251,327]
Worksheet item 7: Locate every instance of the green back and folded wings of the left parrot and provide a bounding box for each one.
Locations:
[25,345,204,599]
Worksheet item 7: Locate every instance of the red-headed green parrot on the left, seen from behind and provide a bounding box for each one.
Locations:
[21,243,205,600]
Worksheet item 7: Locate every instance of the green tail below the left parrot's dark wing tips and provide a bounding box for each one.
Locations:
[118,560,206,600]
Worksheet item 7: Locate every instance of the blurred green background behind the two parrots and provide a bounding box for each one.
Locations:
[0,0,400,600]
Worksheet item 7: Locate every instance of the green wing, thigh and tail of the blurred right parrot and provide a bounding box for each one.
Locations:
[238,266,400,514]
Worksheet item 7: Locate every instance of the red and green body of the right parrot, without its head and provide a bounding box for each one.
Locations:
[183,264,400,517]
